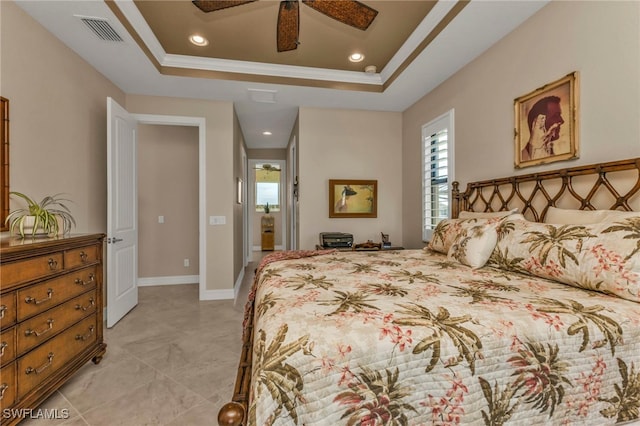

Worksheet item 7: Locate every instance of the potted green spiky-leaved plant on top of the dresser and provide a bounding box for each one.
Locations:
[5,191,76,238]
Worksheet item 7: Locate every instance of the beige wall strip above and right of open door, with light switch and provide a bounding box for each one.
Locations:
[126,95,236,290]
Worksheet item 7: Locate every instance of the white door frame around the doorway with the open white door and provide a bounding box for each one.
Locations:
[131,114,207,300]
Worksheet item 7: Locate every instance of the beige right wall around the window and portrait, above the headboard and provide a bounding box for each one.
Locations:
[402,1,640,247]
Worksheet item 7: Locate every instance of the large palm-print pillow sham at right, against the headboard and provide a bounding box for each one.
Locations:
[488,220,640,302]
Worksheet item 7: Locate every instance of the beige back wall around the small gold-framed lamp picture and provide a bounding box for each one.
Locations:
[298,108,403,249]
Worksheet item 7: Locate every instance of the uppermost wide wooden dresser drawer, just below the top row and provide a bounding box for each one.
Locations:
[17,265,97,321]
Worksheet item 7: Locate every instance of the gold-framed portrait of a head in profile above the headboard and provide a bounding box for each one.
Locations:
[514,71,579,168]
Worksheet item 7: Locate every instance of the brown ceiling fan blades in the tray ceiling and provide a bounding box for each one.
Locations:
[193,0,378,52]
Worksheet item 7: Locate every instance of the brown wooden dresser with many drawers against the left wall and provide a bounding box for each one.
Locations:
[0,234,107,425]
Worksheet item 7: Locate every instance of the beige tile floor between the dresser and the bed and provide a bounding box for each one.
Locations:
[20,254,260,426]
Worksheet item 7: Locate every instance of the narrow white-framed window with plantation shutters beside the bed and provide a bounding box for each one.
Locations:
[422,110,453,241]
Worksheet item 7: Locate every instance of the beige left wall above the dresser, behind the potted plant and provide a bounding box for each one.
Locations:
[0,1,125,232]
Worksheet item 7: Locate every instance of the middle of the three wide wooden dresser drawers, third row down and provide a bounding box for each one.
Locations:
[16,290,96,355]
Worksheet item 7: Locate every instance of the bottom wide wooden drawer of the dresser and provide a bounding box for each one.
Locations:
[17,315,97,398]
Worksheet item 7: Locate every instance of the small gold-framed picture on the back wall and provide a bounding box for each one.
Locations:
[329,179,378,218]
